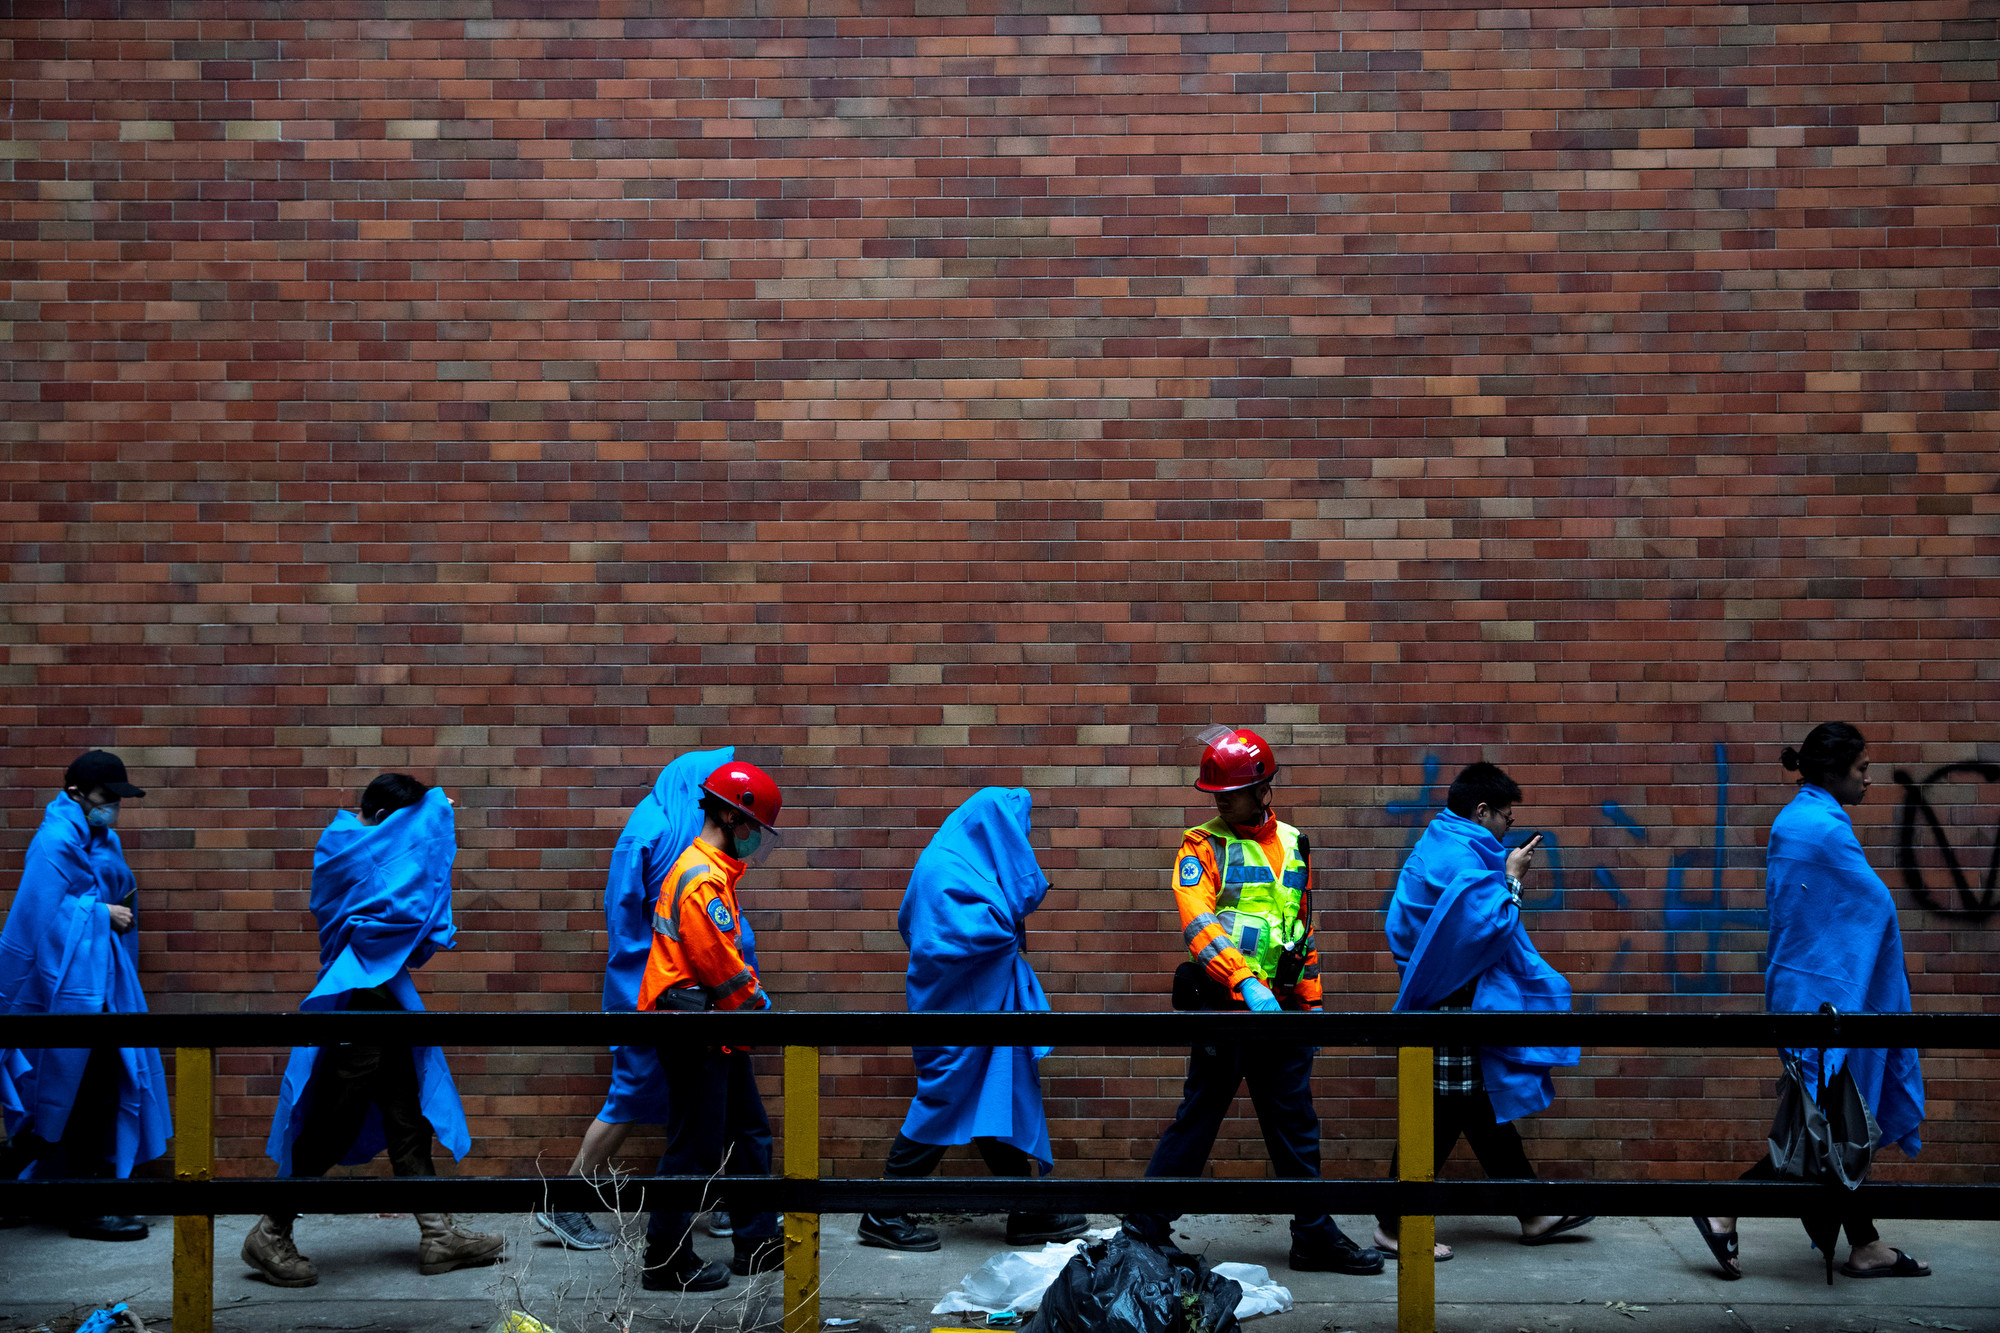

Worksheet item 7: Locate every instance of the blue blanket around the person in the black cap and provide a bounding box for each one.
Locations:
[0,795,174,1177]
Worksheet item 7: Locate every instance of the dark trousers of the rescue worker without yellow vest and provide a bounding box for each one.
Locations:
[646,1047,778,1263]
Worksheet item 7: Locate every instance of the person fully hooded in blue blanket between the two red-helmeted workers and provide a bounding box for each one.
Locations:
[856,787,1090,1251]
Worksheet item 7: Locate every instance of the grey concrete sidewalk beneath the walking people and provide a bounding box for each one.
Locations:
[0,1215,2000,1333]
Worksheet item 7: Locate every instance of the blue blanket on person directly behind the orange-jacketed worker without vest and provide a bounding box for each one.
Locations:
[598,745,736,1125]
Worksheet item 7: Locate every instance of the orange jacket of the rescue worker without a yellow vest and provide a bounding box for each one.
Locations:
[638,839,762,1011]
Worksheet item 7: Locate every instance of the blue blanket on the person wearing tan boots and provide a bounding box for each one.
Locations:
[264,787,472,1175]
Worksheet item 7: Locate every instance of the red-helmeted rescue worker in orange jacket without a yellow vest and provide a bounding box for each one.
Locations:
[638,761,784,1291]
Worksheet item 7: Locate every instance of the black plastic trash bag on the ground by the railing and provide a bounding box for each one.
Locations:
[1022,1231,1244,1333]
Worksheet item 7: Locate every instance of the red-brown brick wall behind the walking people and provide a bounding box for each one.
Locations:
[0,0,2000,1179]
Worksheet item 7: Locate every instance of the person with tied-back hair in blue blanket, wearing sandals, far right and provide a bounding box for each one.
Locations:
[1694,723,1930,1281]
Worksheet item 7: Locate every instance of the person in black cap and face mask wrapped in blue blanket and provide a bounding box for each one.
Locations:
[0,751,174,1241]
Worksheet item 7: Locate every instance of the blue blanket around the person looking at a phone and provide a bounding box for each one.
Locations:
[1388,811,1582,1125]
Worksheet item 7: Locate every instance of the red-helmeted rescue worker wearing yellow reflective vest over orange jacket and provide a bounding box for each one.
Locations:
[1124,731,1382,1273]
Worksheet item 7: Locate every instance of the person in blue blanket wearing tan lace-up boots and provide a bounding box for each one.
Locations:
[242,773,506,1287]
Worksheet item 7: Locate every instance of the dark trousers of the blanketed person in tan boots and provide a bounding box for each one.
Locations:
[272,987,438,1223]
